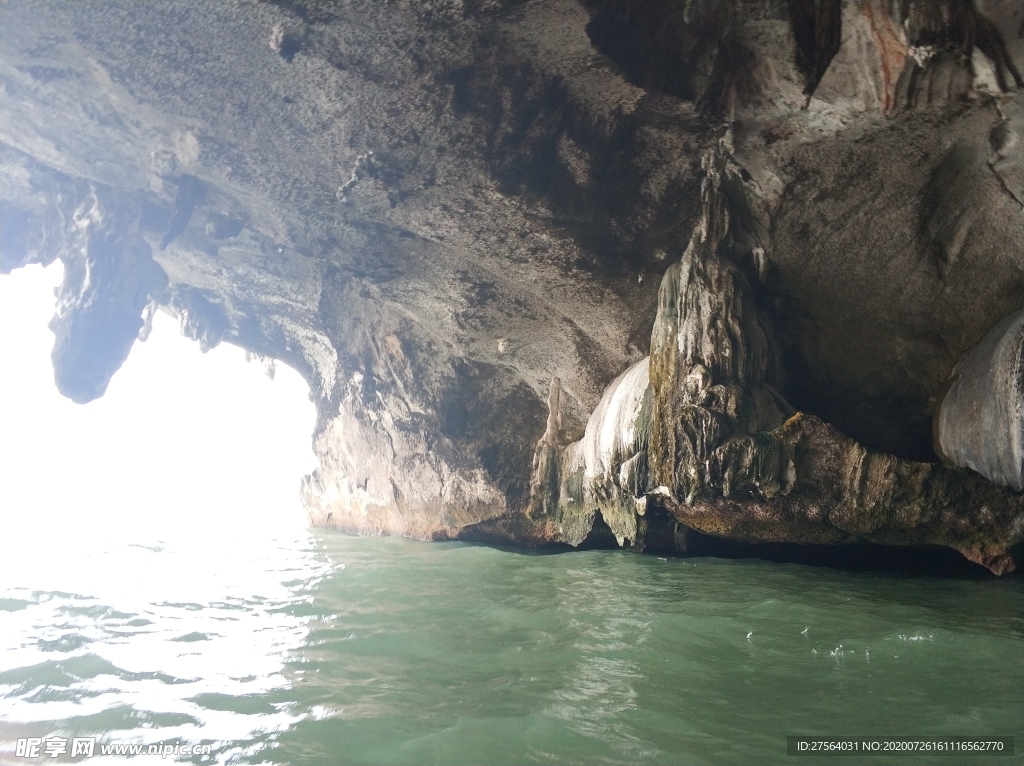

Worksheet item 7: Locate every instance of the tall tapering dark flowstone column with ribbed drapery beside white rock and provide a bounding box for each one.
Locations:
[648,145,793,505]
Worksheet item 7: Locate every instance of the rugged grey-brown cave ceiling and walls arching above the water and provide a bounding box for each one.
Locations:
[0,0,1024,571]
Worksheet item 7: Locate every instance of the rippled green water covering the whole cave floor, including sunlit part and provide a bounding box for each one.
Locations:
[0,531,1024,766]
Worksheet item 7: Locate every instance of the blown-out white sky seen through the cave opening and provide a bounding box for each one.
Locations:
[0,264,315,547]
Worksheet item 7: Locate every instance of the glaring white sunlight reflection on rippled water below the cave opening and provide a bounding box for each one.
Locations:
[0,520,331,758]
